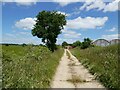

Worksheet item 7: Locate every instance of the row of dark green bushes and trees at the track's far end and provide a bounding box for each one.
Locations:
[62,38,93,49]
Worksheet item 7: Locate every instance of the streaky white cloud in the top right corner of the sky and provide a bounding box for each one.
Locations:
[80,0,120,12]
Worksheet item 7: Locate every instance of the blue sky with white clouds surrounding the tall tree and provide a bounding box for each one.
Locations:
[2,0,119,44]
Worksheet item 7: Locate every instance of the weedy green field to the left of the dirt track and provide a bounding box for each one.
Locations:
[2,45,63,88]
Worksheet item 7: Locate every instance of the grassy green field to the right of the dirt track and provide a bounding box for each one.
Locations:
[71,45,120,88]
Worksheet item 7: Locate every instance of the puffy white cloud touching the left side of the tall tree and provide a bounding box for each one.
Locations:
[15,18,36,30]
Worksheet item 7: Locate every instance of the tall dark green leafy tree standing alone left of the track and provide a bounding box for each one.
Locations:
[32,11,66,52]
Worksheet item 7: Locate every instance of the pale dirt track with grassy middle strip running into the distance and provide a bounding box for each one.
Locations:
[51,49,104,88]
